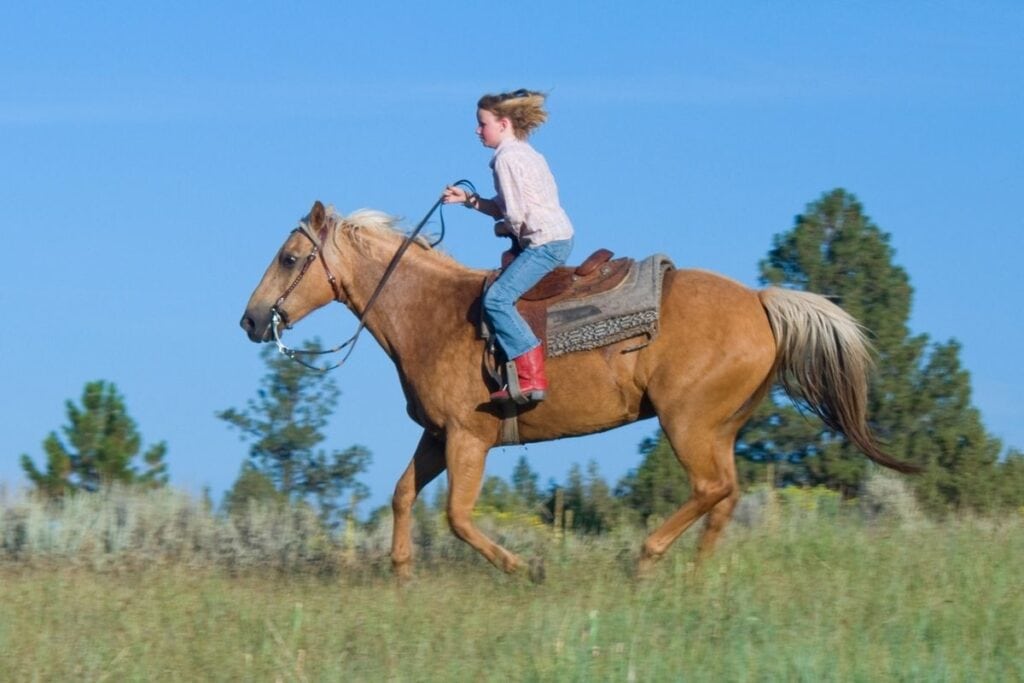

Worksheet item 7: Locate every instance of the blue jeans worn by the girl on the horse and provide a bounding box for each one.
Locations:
[483,238,572,359]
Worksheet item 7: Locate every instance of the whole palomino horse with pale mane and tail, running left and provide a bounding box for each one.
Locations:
[242,202,915,578]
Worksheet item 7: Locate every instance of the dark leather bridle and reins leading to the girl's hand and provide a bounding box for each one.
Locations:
[270,180,476,373]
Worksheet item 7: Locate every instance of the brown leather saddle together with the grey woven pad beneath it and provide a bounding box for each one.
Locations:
[481,249,675,357]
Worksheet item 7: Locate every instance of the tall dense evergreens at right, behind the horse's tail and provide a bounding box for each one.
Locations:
[737,189,999,509]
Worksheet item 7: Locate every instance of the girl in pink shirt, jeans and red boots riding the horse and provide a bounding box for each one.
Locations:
[442,90,572,401]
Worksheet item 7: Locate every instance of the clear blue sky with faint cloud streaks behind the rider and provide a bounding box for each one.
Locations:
[0,2,1024,505]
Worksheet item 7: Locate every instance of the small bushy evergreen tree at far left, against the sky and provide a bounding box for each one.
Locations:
[22,380,167,498]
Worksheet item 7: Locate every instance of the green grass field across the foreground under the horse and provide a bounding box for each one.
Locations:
[0,499,1024,681]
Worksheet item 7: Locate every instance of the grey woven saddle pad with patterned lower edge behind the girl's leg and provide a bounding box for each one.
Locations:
[547,254,675,358]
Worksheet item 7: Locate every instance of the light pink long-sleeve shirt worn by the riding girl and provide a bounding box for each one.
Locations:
[490,138,572,248]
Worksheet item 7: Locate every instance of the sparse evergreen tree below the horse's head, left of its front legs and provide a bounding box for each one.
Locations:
[216,342,370,521]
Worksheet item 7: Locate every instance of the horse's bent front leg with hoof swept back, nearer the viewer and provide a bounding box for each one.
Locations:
[444,432,525,573]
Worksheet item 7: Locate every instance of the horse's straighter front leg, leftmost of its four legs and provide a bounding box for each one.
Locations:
[391,431,444,580]
